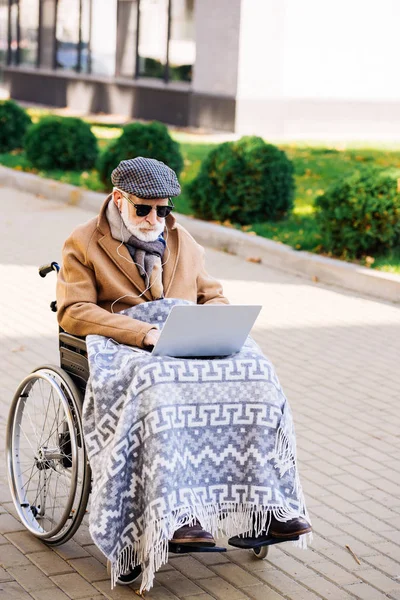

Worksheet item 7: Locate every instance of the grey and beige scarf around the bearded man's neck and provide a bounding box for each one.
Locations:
[106,199,165,300]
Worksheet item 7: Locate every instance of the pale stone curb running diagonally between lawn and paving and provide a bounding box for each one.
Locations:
[0,165,400,302]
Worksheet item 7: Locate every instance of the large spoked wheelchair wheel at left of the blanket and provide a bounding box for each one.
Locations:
[6,365,91,545]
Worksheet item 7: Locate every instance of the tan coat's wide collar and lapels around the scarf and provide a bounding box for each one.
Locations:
[97,195,179,300]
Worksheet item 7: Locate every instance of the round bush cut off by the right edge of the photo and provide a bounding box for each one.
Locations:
[316,171,400,258]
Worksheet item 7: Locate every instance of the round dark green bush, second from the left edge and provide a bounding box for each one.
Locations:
[25,117,98,171]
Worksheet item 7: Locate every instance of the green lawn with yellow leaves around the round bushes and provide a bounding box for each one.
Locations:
[0,116,400,274]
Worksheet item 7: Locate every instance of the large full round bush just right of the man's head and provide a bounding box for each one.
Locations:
[188,136,295,225]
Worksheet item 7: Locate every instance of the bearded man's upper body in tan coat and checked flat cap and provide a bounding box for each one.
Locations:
[57,157,228,347]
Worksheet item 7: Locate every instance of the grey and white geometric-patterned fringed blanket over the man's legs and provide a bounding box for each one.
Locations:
[83,299,308,591]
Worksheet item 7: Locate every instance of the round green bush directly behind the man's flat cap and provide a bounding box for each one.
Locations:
[98,121,183,189]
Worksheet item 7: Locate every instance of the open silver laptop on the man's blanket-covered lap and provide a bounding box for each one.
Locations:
[151,304,261,358]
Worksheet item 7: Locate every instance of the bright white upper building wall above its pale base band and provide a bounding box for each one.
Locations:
[238,0,400,101]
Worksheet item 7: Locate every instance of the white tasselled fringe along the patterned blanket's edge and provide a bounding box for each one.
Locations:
[111,428,312,592]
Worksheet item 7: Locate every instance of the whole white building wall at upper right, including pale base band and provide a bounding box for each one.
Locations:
[236,0,400,139]
